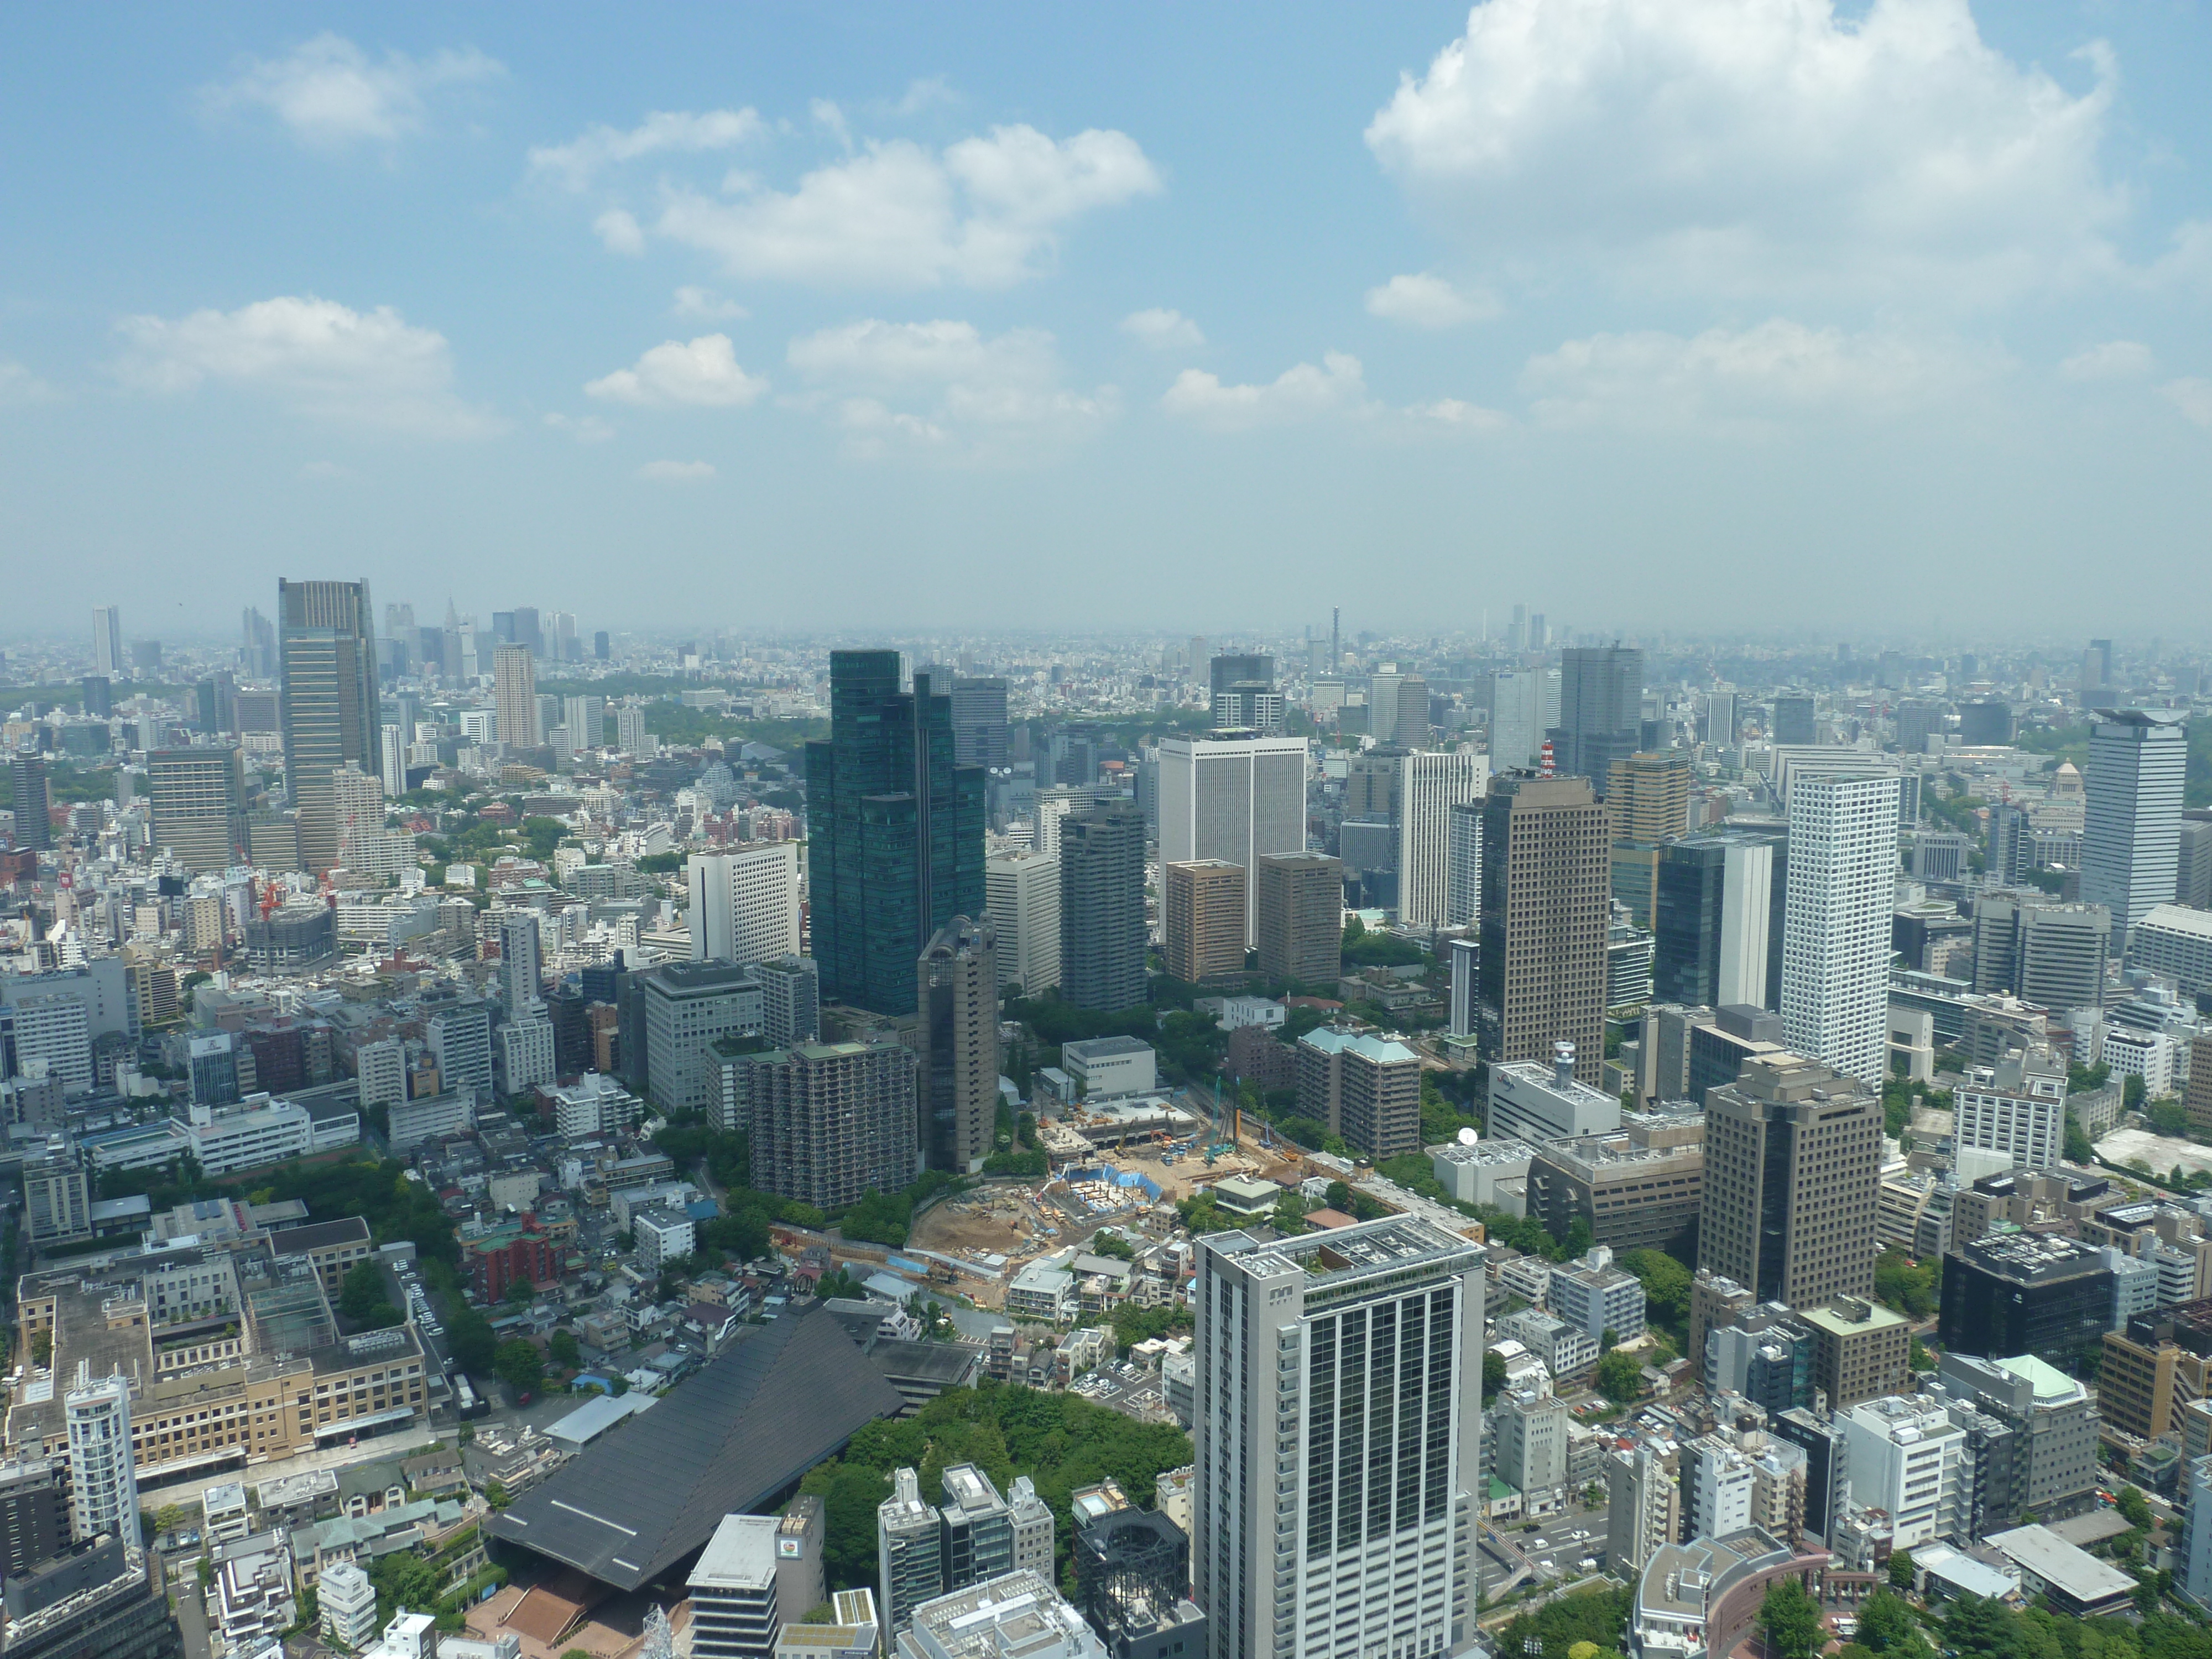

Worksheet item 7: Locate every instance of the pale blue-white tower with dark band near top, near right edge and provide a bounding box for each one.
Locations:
[2079,708,2190,953]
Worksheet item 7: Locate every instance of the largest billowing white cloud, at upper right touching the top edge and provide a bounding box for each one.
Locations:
[1367,0,2126,303]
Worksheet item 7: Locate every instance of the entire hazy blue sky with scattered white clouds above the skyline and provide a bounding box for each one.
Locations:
[0,0,2212,637]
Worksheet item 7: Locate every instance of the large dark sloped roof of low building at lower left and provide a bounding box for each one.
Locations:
[489,1305,902,1590]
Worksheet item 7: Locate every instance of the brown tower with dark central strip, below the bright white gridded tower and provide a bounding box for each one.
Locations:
[1697,1053,1882,1307]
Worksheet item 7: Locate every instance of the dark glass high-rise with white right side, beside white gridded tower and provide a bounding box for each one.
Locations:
[1652,832,1774,1009]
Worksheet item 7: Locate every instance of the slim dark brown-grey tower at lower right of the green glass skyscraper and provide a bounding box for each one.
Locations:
[914,916,998,1175]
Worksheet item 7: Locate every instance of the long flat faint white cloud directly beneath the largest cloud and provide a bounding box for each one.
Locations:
[1522,316,1989,431]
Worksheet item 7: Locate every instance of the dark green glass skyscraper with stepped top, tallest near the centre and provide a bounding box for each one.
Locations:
[807,650,984,1013]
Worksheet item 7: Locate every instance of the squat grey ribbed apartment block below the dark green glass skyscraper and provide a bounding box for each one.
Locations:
[721,1040,916,1210]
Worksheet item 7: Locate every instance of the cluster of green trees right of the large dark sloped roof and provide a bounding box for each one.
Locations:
[801,1385,1194,1601]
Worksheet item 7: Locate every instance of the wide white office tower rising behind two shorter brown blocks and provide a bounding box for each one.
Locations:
[1159,734,1307,947]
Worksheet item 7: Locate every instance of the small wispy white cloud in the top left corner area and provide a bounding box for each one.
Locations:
[199,33,507,148]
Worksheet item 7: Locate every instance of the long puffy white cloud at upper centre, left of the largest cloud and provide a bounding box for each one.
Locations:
[655,126,1161,288]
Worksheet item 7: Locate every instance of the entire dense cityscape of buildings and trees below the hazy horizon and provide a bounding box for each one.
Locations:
[0,580,2212,1659]
